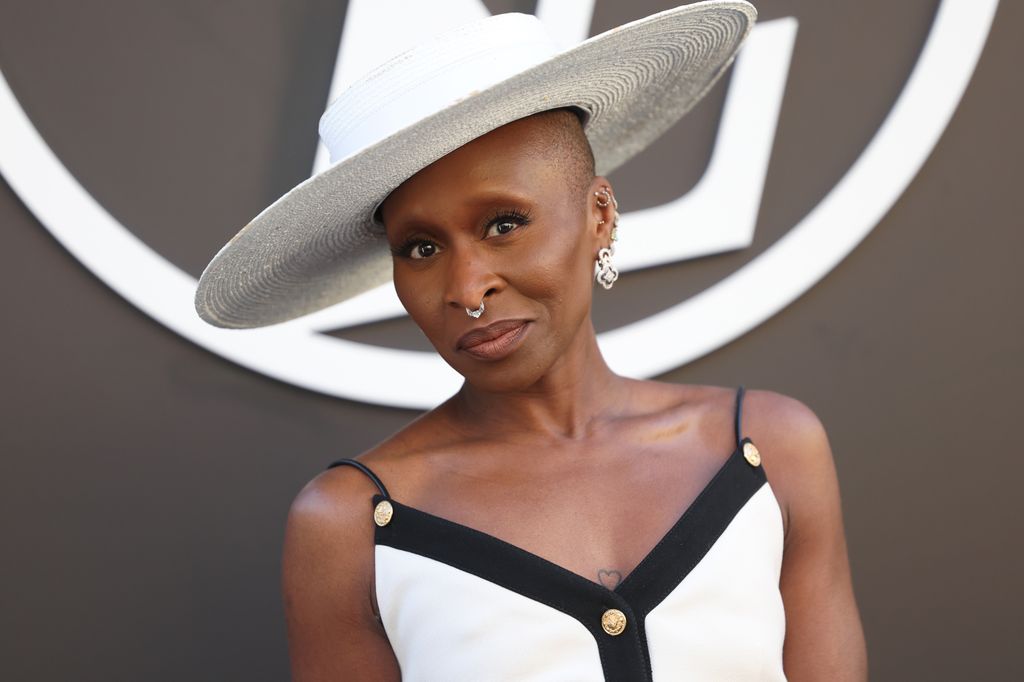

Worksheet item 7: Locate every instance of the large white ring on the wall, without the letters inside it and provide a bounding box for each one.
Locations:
[0,0,998,408]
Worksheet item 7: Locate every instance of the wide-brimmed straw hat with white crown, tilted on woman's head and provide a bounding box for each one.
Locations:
[196,0,757,329]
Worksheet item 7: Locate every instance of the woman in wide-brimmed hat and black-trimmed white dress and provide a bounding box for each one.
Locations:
[197,2,866,682]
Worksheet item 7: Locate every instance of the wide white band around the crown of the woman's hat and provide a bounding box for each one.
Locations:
[319,14,560,164]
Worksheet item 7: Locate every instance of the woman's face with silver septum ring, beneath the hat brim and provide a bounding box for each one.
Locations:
[381,113,611,391]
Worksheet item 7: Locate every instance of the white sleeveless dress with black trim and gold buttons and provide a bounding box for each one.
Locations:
[328,386,785,682]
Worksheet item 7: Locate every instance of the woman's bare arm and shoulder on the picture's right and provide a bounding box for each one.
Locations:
[744,391,867,682]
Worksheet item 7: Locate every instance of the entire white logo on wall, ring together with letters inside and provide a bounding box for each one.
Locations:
[0,0,998,408]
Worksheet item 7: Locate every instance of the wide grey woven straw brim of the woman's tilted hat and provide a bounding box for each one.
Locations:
[196,0,757,329]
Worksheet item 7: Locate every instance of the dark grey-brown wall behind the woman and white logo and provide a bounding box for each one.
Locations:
[0,0,1024,680]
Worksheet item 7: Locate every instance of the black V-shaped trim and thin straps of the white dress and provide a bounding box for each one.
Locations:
[328,386,767,682]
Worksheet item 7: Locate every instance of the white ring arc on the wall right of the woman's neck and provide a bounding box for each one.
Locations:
[601,0,998,376]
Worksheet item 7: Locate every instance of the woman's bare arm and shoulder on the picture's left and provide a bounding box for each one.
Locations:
[282,466,400,682]
